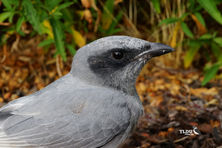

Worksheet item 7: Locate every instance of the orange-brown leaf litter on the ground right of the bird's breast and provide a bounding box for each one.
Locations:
[124,64,222,148]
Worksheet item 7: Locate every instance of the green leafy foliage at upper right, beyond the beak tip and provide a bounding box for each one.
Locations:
[160,0,222,85]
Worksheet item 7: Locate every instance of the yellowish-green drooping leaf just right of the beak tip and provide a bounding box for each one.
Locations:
[184,40,201,68]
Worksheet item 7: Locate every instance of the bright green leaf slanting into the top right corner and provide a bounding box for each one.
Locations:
[197,0,222,24]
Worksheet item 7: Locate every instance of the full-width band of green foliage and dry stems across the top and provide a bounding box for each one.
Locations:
[0,0,222,85]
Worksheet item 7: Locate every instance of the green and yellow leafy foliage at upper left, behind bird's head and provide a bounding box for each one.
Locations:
[0,0,121,61]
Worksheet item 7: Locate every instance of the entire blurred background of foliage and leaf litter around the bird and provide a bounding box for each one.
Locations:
[0,0,222,148]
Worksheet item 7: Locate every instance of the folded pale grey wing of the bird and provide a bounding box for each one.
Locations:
[0,88,130,148]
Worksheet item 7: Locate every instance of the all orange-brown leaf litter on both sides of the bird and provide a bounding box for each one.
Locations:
[0,37,222,148]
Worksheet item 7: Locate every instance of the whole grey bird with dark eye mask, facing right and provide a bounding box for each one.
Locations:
[0,36,173,148]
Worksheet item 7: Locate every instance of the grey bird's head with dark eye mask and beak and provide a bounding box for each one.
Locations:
[71,36,173,95]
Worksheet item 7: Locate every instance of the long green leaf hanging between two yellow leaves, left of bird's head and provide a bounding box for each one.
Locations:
[50,18,66,61]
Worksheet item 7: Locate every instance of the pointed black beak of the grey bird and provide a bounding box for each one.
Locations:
[134,43,174,59]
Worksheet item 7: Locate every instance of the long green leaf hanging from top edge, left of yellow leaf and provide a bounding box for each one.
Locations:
[22,0,42,34]
